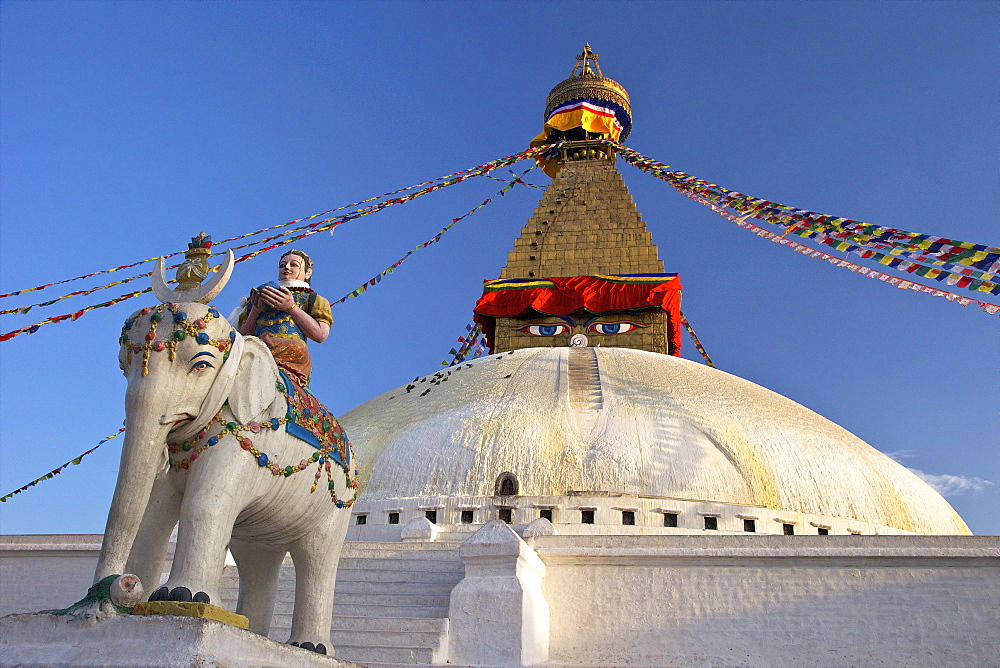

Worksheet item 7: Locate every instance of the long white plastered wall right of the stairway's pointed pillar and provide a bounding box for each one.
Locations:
[534,536,1000,666]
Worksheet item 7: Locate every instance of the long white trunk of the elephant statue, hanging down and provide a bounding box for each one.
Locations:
[94,384,172,582]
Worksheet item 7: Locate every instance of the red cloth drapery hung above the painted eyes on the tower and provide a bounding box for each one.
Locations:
[474,274,681,356]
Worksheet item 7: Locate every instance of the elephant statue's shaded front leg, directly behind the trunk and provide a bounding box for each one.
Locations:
[125,477,181,596]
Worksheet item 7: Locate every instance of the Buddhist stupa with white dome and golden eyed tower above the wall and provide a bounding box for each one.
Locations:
[345,45,969,539]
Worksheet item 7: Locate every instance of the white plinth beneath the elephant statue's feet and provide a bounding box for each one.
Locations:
[0,614,354,668]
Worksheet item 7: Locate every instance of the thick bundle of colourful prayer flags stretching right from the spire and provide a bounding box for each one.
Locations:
[607,142,1000,304]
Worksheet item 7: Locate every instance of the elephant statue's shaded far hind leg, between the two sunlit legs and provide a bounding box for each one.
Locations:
[229,538,288,636]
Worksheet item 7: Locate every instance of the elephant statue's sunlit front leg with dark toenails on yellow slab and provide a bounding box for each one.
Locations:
[166,480,242,605]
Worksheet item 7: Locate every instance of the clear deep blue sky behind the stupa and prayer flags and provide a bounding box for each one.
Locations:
[0,1,1000,534]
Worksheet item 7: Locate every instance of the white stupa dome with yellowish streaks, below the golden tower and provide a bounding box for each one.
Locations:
[341,348,970,535]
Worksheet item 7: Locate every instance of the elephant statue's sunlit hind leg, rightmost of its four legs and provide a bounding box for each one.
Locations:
[288,509,351,656]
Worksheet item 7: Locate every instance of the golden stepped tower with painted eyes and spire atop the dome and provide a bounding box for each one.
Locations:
[476,45,681,355]
